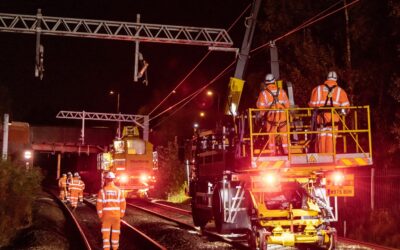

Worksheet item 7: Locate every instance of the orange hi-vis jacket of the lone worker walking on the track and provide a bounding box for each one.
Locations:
[96,182,126,219]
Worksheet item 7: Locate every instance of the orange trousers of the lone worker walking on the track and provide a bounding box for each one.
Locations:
[101,216,121,250]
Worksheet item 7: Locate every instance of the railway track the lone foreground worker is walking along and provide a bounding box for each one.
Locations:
[48,191,167,250]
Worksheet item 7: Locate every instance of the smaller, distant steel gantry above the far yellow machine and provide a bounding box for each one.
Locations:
[56,111,149,144]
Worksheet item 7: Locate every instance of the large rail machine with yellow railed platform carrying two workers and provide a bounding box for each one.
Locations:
[190,80,372,249]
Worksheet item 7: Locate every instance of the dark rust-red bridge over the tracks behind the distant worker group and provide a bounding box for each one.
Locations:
[1,122,115,178]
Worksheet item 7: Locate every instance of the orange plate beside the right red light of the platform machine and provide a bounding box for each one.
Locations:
[326,174,354,197]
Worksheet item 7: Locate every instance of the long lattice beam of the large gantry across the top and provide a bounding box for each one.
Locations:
[0,13,233,47]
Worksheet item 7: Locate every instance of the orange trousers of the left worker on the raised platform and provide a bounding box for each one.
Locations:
[267,111,288,154]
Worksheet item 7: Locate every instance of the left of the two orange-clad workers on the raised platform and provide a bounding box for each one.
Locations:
[257,74,289,155]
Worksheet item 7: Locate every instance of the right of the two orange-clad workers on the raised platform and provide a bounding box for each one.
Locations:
[308,71,350,153]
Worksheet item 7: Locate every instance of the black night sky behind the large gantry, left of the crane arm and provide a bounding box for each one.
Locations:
[0,0,250,135]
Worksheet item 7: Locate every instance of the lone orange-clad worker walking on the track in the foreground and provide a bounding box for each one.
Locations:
[96,172,126,250]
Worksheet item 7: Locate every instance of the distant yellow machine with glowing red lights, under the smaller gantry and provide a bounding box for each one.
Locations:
[98,126,157,197]
